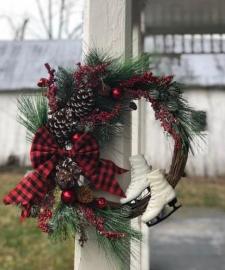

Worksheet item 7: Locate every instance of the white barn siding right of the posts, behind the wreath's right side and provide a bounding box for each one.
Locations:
[145,88,225,176]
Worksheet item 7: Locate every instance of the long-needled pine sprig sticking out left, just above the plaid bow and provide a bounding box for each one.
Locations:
[18,94,48,141]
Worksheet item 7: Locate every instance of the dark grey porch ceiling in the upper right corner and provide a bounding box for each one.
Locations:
[145,0,225,35]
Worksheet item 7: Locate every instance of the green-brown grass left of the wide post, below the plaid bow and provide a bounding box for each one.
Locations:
[0,170,74,270]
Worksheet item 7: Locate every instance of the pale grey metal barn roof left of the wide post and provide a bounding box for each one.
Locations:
[0,40,81,91]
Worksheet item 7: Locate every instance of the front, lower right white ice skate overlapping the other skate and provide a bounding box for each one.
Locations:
[141,170,181,227]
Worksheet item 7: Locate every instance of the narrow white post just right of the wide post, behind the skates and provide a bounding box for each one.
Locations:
[131,1,150,270]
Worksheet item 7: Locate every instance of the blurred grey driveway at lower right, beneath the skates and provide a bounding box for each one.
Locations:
[150,208,225,270]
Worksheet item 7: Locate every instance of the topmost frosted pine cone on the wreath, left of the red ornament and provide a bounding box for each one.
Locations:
[68,89,95,117]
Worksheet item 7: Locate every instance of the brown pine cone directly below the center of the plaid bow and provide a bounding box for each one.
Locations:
[56,158,81,190]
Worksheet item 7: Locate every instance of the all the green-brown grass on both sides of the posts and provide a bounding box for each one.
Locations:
[0,169,225,270]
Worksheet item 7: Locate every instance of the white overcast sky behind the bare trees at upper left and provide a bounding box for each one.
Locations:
[0,0,83,40]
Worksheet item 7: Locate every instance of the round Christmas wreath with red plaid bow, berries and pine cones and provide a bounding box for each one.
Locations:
[4,50,203,265]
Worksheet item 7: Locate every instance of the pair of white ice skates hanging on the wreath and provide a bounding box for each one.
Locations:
[120,155,181,227]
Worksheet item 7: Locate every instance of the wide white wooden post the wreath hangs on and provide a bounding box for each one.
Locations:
[74,0,132,270]
